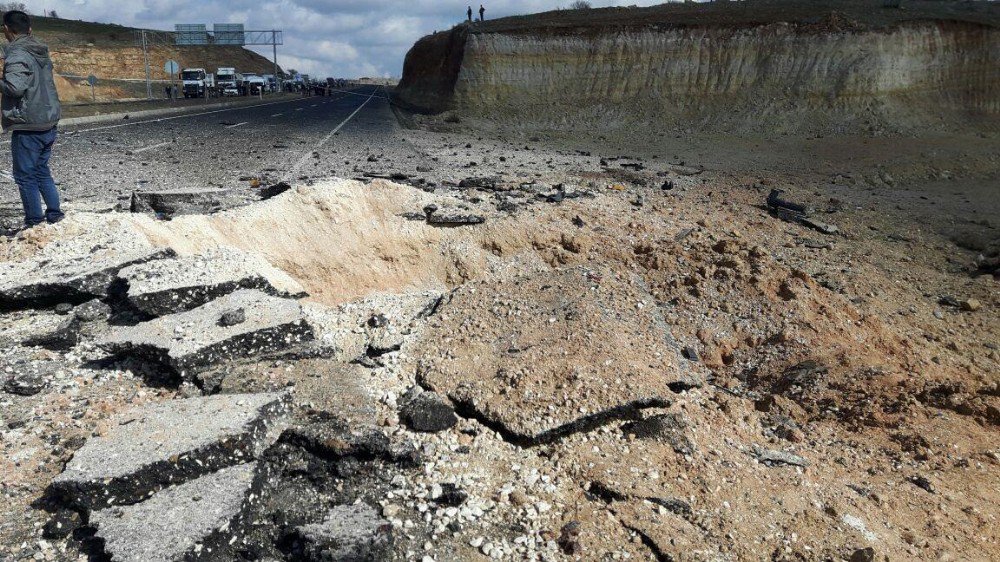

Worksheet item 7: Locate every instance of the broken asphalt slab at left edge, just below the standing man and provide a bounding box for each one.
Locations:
[0,248,175,310]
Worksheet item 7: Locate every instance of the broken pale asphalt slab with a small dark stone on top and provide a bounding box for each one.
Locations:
[98,289,314,377]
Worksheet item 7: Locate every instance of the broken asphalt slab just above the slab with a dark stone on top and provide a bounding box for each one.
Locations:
[118,248,305,316]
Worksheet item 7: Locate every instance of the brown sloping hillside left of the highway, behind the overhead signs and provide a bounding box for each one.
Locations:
[32,17,274,102]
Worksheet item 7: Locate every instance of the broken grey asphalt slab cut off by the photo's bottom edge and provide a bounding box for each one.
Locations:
[90,463,263,562]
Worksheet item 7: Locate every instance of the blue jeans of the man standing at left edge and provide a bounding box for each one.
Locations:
[10,127,63,226]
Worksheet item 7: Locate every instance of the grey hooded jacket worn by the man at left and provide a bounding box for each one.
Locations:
[0,35,61,131]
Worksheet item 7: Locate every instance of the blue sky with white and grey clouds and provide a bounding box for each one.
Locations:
[33,0,663,78]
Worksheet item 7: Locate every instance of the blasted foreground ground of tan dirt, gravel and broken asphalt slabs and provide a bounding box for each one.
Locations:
[0,100,1000,562]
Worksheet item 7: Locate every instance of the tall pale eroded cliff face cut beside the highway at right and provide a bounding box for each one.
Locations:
[399,22,1000,133]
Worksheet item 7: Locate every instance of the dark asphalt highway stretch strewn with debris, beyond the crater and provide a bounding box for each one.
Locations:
[0,86,416,208]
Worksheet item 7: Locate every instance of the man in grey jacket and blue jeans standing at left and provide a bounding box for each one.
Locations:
[0,11,63,227]
